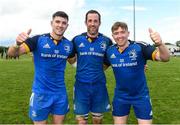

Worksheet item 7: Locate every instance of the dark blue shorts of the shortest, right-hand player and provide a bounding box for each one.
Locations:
[112,96,152,120]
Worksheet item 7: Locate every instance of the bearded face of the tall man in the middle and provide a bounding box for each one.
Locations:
[85,13,100,35]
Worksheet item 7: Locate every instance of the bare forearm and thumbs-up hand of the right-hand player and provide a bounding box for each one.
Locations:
[149,29,170,62]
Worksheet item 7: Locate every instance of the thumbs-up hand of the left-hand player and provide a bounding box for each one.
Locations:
[16,29,32,46]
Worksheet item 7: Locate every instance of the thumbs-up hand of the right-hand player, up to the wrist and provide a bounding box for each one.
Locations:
[149,28,162,46]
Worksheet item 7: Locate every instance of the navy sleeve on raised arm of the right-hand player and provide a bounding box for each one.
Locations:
[139,42,156,60]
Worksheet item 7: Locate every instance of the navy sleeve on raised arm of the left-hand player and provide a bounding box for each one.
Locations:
[25,35,39,52]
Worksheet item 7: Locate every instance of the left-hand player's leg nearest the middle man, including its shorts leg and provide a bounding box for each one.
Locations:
[51,90,69,124]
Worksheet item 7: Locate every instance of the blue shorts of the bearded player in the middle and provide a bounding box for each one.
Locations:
[74,82,110,115]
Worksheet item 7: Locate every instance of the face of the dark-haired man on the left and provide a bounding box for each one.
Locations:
[51,16,68,36]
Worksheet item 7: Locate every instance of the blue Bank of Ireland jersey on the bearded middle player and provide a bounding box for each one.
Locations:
[71,33,112,83]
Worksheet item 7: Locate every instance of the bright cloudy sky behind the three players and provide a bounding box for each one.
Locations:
[0,0,180,46]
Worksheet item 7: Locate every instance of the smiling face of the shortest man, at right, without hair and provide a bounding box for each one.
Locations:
[112,27,129,47]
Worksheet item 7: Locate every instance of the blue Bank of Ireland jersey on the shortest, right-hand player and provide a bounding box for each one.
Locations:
[106,41,155,98]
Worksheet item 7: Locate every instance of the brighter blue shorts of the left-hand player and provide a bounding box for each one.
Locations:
[29,93,69,121]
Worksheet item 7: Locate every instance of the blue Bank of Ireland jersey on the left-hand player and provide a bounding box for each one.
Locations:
[25,34,73,93]
